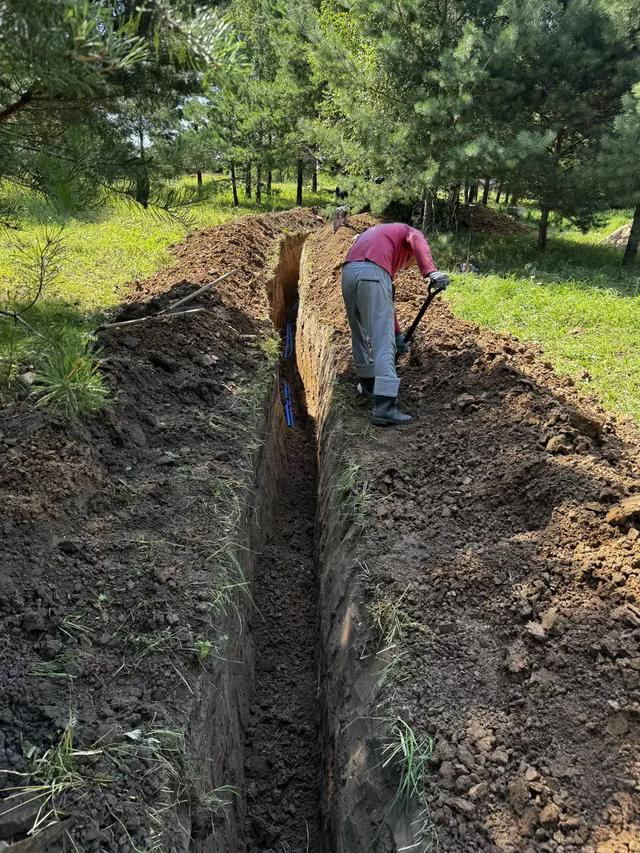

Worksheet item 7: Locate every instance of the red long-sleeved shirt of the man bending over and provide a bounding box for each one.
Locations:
[347,222,437,278]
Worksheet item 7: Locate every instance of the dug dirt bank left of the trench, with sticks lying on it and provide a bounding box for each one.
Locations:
[0,210,319,853]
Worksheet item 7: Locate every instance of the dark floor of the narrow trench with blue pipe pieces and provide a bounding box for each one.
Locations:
[245,239,321,853]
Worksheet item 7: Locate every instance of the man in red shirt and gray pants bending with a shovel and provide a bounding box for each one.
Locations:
[342,222,449,426]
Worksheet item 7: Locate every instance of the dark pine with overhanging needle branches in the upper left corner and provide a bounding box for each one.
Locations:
[0,0,234,220]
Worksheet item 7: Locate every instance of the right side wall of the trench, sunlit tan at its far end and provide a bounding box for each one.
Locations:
[297,234,416,853]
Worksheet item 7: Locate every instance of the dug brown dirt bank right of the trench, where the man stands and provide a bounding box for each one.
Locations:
[302,217,640,853]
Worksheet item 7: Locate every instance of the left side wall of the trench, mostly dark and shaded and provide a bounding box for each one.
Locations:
[178,233,307,853]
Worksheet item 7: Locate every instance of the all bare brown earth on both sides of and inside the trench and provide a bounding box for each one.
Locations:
[0,206,640,853]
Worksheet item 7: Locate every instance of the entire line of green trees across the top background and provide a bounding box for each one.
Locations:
[0,0,640,263]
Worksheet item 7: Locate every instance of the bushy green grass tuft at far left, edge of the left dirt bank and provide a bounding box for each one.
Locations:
[33,331,107,417]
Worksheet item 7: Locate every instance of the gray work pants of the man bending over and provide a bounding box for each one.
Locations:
[342,261,400,397]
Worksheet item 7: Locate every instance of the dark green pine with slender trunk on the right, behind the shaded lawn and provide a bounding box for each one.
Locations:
[480,0,635,250]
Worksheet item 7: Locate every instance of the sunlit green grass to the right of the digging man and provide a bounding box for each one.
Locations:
[433,212,640,421]
